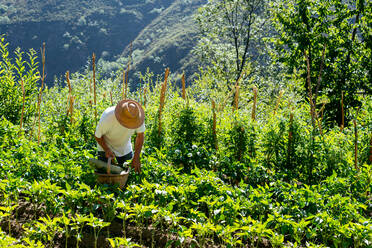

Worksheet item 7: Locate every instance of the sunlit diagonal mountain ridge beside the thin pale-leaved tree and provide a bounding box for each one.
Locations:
[117,0,206,83]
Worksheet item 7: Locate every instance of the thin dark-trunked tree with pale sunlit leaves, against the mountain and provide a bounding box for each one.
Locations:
[196,0,266,85]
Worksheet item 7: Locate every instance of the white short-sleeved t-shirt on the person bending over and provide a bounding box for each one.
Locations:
[95,106,146,157]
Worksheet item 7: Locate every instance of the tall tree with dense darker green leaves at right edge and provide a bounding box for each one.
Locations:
[273,0,372,125]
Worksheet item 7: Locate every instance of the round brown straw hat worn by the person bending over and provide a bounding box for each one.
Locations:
[115,99,145,129]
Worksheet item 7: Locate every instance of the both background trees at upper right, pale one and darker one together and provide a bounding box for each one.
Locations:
[195,0,372,126]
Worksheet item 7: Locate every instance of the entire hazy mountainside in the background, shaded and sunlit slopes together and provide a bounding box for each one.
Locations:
[0,0,205,84]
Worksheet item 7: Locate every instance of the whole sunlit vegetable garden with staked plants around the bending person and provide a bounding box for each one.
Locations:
[0,35,372,247]
